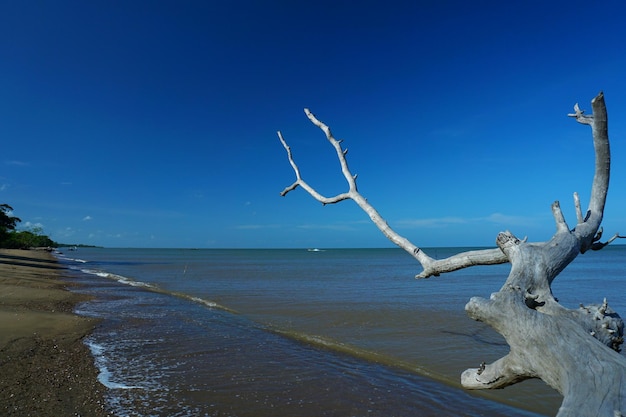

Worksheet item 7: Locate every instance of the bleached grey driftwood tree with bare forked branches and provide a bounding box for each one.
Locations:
[278,93,626,417]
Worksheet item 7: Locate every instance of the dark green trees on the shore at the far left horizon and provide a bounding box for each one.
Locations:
[0,204,57,249]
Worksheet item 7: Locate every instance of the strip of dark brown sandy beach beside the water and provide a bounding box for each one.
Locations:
[0,249,108,417]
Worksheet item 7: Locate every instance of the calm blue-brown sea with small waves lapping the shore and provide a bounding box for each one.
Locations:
[57,245,626,417]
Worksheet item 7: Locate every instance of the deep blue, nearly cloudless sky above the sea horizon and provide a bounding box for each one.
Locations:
[0,0,626,248]
